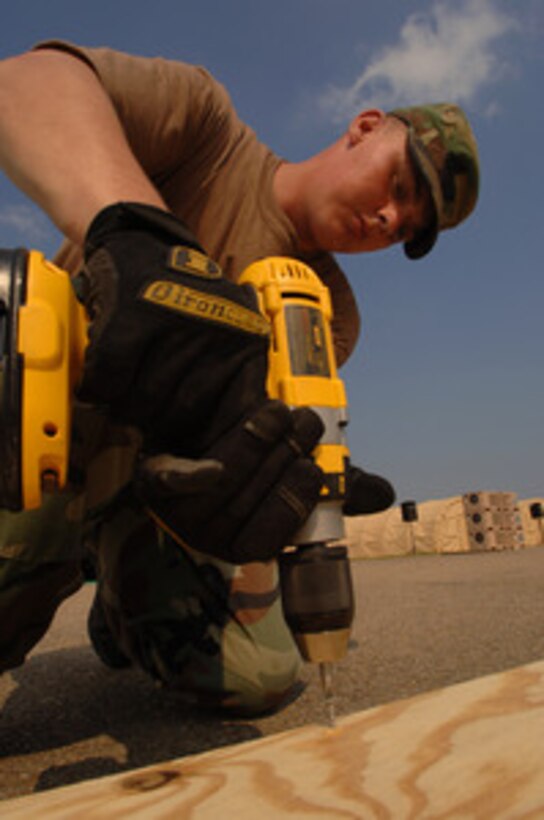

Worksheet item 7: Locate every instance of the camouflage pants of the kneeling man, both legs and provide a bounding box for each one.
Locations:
[0,490,300,713]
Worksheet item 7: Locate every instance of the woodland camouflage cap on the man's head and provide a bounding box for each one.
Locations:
[389,103,479,259]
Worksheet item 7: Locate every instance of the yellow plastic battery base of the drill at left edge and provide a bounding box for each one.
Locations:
[17,251,87,509]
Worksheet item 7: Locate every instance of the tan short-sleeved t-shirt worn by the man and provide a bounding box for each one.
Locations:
[39,41,359,364]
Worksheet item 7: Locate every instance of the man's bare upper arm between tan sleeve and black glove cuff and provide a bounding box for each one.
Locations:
[0,50,165,245]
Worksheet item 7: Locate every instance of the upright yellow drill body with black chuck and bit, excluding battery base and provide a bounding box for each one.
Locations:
[240,257,354,724]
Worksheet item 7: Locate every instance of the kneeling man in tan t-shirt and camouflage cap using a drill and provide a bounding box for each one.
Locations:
[0,42,478,711]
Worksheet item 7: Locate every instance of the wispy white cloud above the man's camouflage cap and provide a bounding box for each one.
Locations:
[321,0,517,120]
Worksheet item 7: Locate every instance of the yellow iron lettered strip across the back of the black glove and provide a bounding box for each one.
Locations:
[141,279,270,336]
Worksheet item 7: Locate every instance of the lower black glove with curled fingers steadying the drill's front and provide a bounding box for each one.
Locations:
[134,400,323,564]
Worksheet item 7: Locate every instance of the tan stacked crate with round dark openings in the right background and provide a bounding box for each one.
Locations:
[463,492,525,552]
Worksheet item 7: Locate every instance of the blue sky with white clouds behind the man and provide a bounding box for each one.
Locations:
[0,0,544,502]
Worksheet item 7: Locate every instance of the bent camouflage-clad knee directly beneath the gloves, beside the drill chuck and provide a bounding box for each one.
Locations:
[91,500,299,712]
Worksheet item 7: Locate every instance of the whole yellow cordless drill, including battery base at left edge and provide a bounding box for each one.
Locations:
[0,250,354,722]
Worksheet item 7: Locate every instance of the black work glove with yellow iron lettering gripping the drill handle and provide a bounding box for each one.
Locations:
[77,203,269,456]
